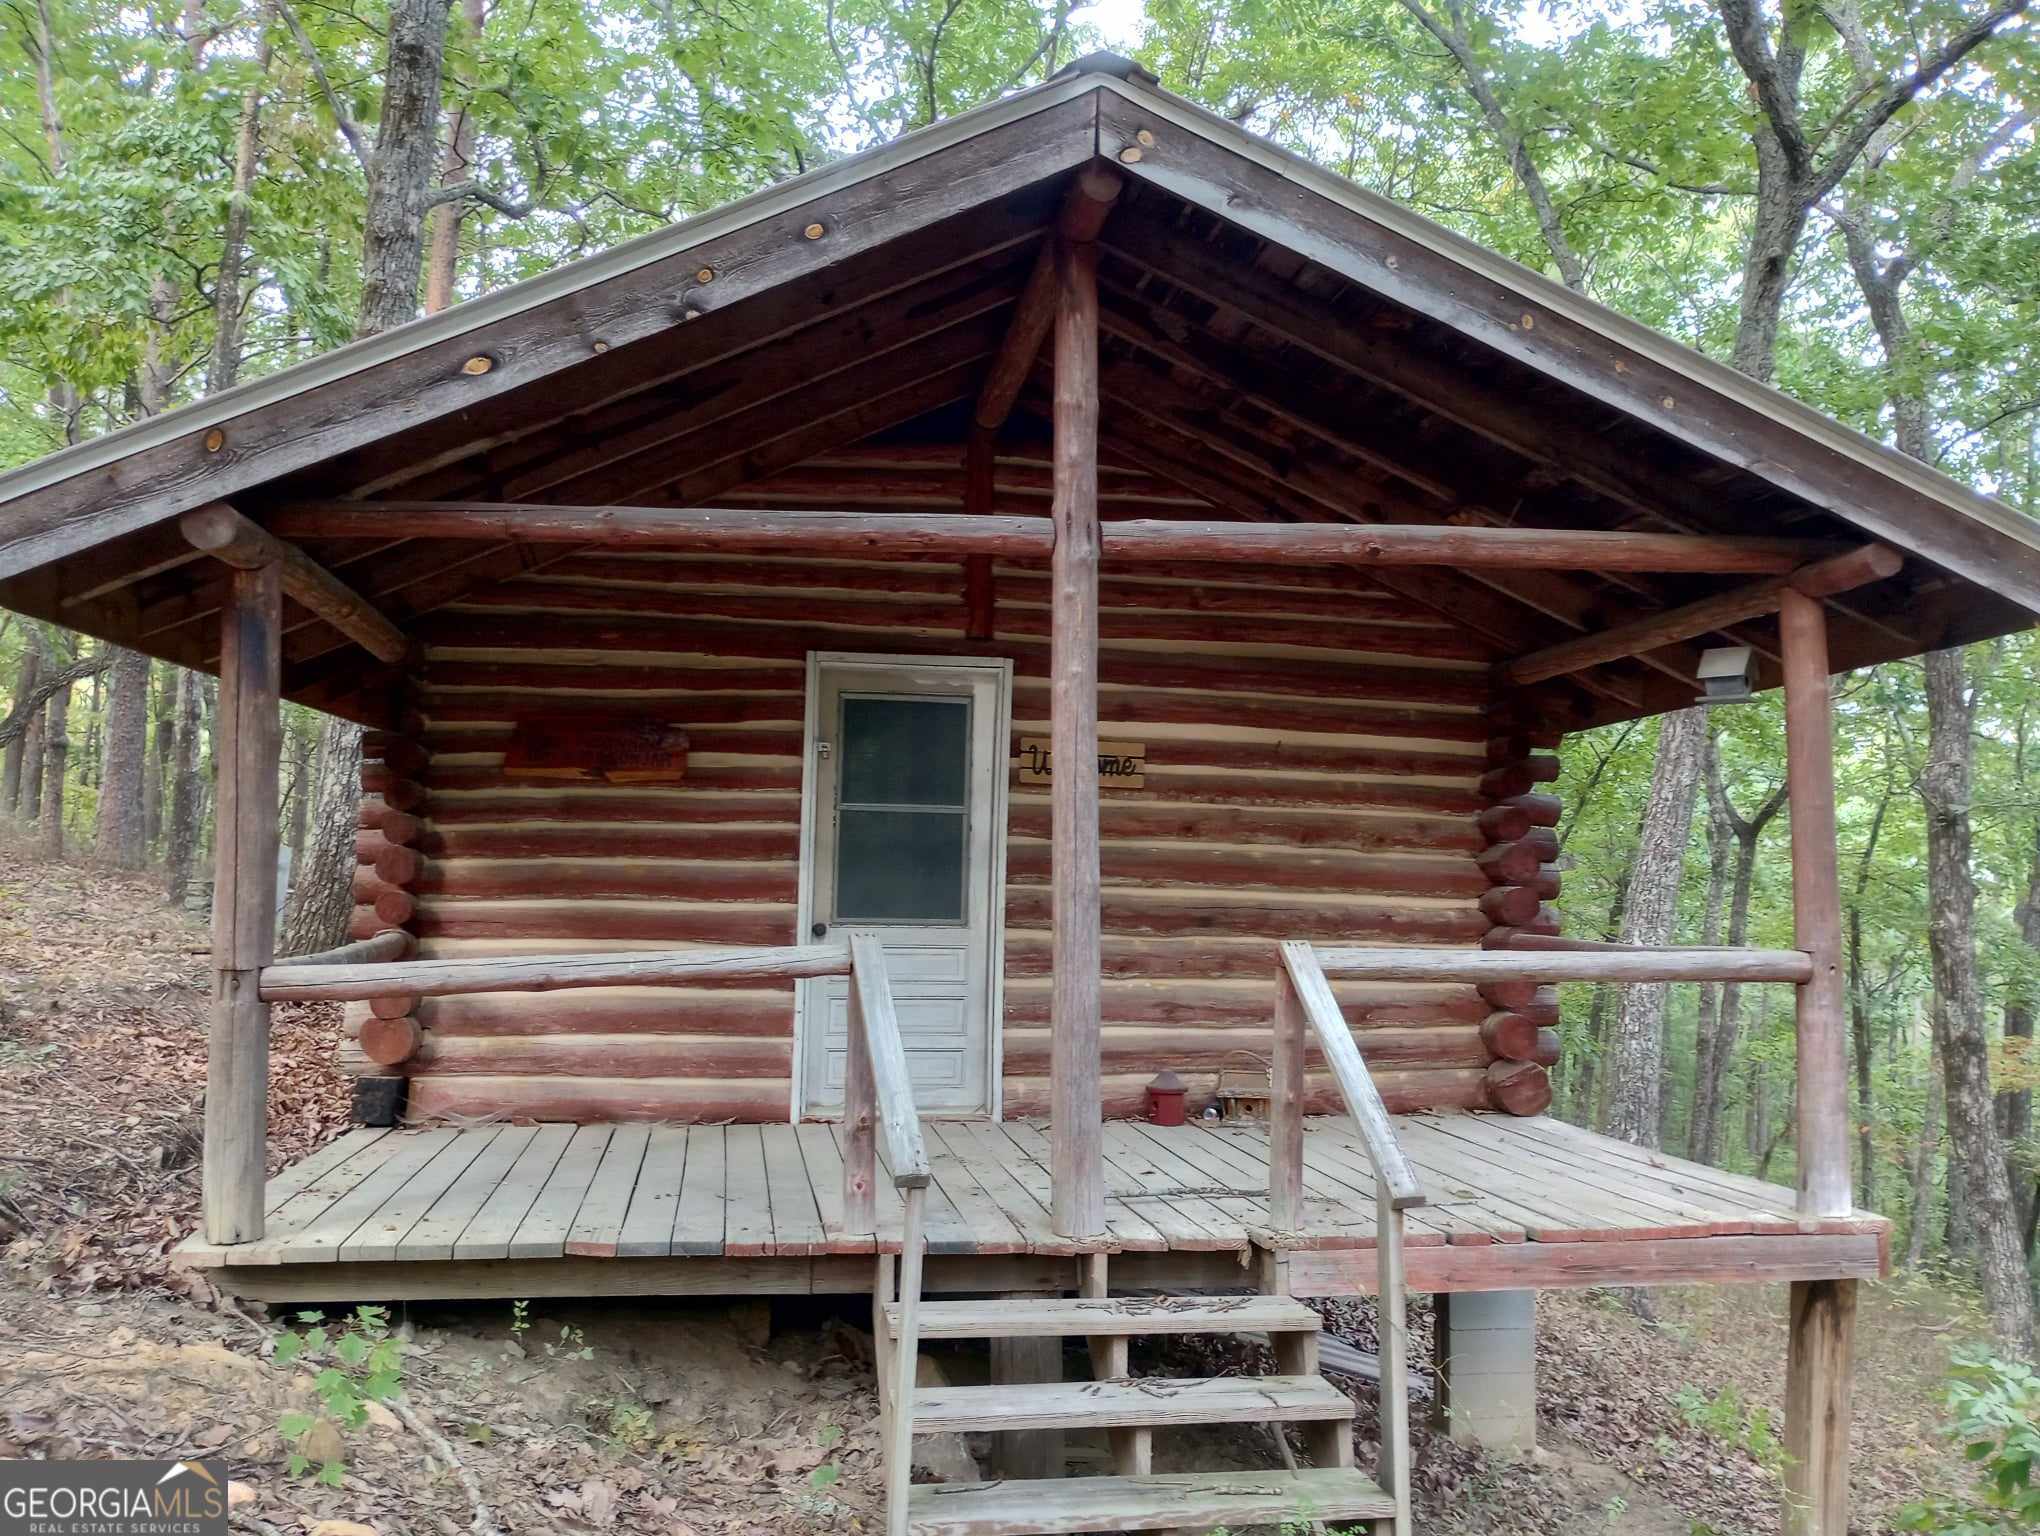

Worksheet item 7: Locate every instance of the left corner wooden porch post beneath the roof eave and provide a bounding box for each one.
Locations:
[202,563,284,1242]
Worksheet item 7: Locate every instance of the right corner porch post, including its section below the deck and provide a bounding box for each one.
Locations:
[1779,590,1856,1536]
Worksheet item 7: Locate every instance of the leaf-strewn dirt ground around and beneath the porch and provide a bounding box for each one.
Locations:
[0,834,1977,1536]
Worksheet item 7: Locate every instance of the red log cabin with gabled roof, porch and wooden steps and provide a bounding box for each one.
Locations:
[0,55,2040,1536]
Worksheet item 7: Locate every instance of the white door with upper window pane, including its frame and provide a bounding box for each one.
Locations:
[798,655,1012,1118]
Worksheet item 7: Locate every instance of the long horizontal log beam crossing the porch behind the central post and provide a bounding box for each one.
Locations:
[271,502,1840,575]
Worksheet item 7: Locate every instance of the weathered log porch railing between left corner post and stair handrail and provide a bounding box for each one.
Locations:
[259,944,851,1002]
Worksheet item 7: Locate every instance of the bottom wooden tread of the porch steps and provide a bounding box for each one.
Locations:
[908,1467,1395,1536]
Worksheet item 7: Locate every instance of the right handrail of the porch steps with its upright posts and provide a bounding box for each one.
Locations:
[1269,938,1424,1536]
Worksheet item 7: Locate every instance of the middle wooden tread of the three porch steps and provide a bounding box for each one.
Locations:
[914,1377,1353,1434]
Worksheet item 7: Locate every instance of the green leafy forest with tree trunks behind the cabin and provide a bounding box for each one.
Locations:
[0,0,2040,1348]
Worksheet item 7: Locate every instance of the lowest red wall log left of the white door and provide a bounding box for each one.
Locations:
[408,1073,794,1126]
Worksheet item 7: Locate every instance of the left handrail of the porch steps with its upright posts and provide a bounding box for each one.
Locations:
[843,934,930,1536]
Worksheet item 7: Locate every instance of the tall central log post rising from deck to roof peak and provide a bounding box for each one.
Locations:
[1049,239,1106,1238]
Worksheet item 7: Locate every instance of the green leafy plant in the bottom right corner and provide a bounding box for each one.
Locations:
[1899,1348,2040,1536]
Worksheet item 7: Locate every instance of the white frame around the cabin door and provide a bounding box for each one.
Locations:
[787,651,1014,1124]
